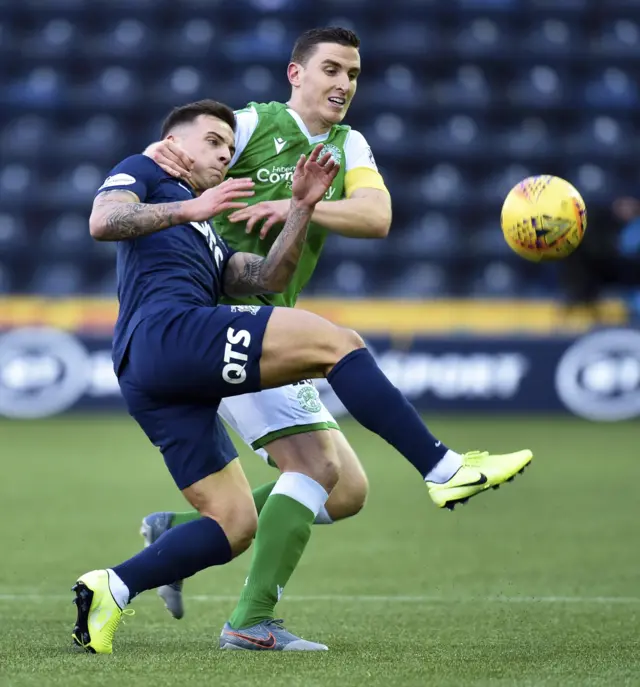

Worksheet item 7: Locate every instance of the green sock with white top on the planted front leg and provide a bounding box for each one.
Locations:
[229,472,327,629]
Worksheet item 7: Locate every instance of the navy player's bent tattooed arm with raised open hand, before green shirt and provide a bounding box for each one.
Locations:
[224,144,339,296]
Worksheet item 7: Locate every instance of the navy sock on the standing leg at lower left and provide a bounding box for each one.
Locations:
[113,518,232,601]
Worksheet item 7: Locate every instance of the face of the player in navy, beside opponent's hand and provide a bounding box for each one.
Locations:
[170,115,236,191]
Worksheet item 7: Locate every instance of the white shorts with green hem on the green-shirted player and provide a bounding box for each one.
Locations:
[218,379,339,460]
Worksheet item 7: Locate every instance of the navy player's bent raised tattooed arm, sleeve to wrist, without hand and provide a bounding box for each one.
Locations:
[223,201,313,296]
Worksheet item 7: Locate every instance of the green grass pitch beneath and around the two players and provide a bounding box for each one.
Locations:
[0,416,640,687]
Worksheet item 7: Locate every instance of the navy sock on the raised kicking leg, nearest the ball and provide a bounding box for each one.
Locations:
[327,348,449,478]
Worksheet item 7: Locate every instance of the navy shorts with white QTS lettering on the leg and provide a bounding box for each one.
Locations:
[118,305,273,489]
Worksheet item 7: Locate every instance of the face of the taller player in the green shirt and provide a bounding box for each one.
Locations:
[297,43,360,124]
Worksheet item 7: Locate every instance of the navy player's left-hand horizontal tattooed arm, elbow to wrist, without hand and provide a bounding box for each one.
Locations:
[89,189,189,241]
